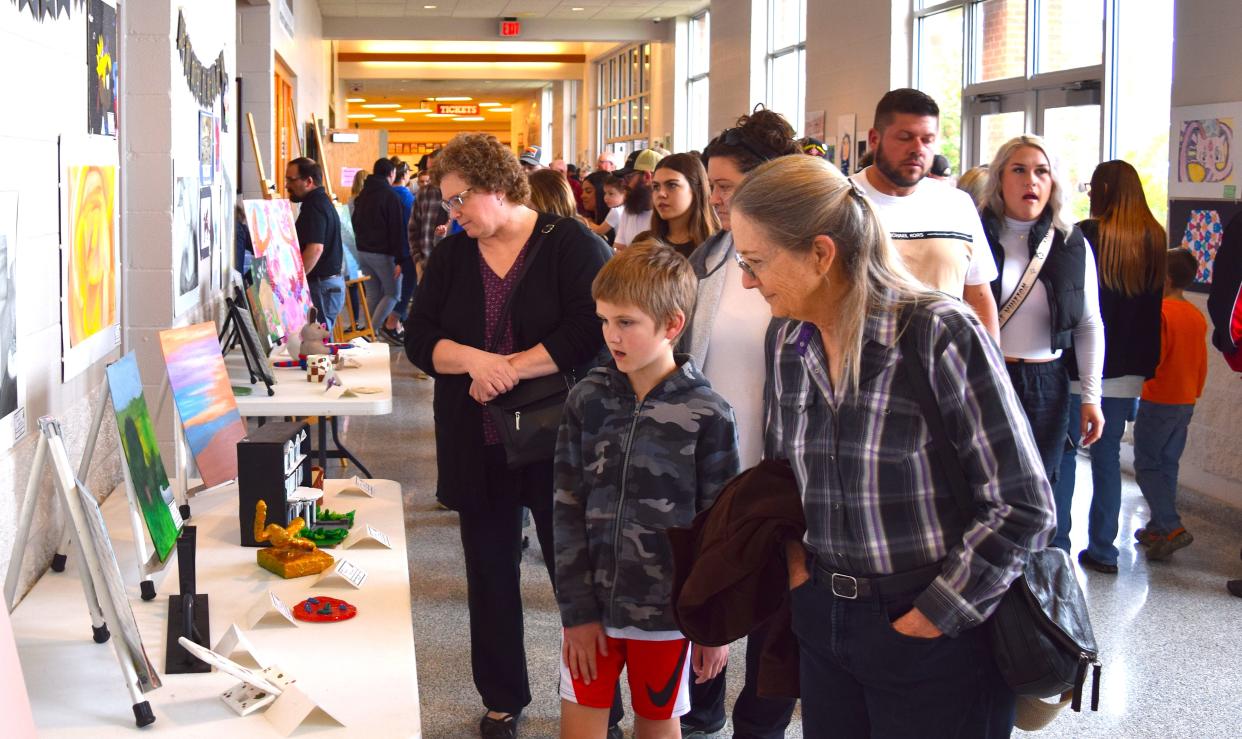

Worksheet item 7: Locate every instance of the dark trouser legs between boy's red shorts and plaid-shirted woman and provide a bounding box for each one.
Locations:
[682,626,797,739]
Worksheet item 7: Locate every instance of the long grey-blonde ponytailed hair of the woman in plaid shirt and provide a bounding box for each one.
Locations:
[729,156,932,395]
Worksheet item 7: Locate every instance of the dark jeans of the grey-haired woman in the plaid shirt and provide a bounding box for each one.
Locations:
[792,571,1015,739]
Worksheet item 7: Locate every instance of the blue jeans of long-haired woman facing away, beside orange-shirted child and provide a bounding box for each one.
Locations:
[1052,395,1139,565]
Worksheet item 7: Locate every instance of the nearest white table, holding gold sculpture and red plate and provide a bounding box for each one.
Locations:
[12,479,421,739]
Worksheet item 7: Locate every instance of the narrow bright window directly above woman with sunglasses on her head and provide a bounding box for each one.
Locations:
[768,0,806,135]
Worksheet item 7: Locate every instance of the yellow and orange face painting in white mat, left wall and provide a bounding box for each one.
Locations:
[65,165,119,347]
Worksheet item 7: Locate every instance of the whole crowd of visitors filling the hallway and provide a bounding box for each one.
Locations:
[244,89,1242,739]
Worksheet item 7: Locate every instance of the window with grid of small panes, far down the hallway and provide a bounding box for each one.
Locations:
[595,43,651,154]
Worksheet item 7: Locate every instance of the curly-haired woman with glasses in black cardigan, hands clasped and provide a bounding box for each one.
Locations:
[405,134,610,737]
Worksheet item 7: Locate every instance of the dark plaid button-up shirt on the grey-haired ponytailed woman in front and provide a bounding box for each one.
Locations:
[764,294,1056,636]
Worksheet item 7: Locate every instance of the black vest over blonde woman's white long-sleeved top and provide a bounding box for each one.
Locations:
[980,209,1087,350]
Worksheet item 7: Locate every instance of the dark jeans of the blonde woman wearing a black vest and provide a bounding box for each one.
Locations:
[1005,359,1071,484]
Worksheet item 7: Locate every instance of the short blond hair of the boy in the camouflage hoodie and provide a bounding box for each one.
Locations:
[591,237,698,330]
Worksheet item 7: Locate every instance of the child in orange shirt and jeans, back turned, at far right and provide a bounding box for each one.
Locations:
[1134,248,1207,560]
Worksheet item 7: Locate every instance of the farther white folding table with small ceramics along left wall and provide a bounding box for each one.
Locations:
[225,343,392,477]
